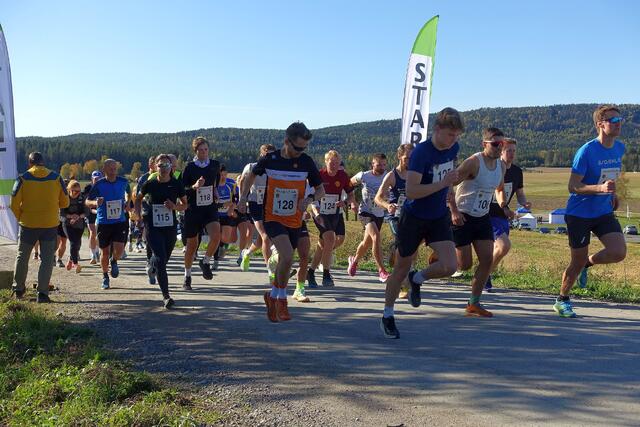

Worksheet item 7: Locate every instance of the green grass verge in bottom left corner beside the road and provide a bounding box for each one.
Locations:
[0,291,220,426]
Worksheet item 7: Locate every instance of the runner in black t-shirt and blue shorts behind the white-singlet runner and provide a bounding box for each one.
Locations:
[484,138,531,292]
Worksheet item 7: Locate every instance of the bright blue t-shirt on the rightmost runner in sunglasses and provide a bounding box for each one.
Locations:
[567,138,625,218]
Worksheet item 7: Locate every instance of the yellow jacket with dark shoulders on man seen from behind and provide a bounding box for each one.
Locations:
[11,166,69,228]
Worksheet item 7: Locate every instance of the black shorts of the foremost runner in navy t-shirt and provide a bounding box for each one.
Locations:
[396,210,453,258]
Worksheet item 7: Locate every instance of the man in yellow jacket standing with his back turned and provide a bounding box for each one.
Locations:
[11,151,69,302]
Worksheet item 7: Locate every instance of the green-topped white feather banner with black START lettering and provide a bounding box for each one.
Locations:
[401,16,438,145]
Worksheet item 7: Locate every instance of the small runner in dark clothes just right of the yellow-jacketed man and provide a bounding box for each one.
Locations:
[60,179,91,273]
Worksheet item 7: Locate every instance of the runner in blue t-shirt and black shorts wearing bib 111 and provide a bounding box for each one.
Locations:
[85,159,131,289]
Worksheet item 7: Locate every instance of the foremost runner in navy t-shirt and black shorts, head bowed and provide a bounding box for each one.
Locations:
[380,108,464,338]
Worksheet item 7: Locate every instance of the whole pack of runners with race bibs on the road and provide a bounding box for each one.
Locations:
[32,105,626,338]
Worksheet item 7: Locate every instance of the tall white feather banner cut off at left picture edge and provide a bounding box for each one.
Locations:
[0,26,18,242]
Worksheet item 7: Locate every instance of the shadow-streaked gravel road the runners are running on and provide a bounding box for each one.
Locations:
[0,237,640,426]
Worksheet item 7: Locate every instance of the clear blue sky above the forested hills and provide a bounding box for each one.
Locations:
[0,0,640,136]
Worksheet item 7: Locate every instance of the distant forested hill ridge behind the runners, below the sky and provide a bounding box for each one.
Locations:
[18,104,640,178]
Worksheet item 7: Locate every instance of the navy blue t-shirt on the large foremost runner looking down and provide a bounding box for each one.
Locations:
[404,138,460,219]
